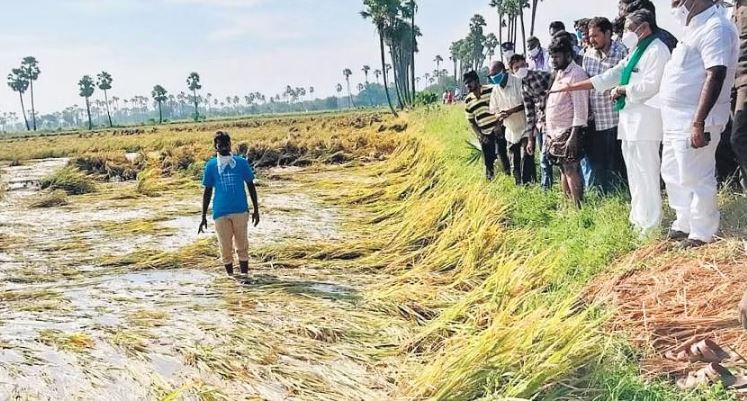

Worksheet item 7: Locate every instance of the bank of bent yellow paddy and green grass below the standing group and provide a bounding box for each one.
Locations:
[254,108,729,400]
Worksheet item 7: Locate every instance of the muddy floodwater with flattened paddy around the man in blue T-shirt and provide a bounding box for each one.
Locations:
[0,159,400,400]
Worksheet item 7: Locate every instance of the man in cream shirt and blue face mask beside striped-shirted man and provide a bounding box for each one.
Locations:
[488,61,537,185]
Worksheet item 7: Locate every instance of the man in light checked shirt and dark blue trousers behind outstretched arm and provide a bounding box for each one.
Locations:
[581,17,628,193]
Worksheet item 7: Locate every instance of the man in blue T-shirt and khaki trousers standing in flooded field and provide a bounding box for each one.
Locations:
[197,131,259,275]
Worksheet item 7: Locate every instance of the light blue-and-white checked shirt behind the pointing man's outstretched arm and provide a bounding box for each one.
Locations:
[583,42,628,131]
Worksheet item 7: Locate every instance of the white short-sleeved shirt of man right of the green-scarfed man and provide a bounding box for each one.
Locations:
[660,6,739,138]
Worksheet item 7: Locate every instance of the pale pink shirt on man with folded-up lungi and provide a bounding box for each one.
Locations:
[547,62,589,137]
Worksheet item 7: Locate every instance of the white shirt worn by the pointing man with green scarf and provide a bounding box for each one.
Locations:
[591,39,671,141]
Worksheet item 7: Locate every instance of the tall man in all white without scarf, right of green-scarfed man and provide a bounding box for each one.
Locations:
[660,0,739,248]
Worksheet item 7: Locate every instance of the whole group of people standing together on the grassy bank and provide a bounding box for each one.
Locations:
[464,0,747,247]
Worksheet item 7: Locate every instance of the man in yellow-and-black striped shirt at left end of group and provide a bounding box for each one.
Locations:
[463,71,511,181]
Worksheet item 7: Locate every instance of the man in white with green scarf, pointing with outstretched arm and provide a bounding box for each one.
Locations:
[548,10,670,234]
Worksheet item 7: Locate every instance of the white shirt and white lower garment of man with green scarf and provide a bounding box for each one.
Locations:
[591,39,670,233]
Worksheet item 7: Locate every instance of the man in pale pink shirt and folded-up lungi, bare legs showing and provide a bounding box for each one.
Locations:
[545,38,589,207]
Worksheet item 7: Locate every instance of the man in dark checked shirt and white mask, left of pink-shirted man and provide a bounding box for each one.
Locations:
[508,53,553,189]
